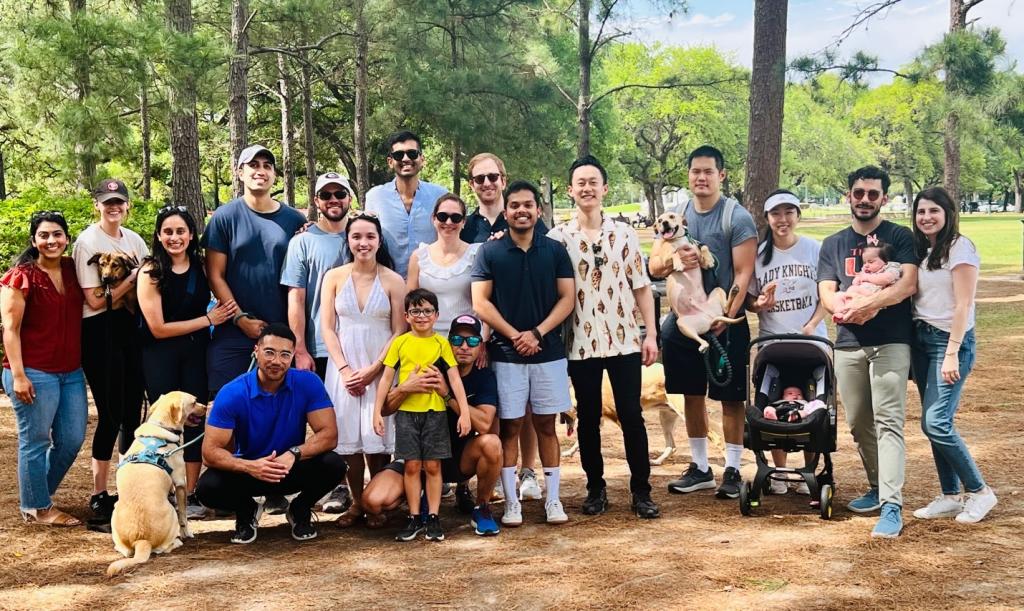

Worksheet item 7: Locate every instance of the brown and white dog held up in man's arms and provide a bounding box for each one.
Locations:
[650,212,742,352]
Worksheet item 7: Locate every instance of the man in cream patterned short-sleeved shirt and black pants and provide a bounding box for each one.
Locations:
[548,155,659,519]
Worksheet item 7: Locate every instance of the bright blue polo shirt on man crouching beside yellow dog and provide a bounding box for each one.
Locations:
[206,369,334,460]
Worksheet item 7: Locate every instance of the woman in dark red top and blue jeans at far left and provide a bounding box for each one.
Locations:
[0,212,88,526]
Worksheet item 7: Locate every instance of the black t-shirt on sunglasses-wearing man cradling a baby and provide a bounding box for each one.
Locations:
[818,221,918,348]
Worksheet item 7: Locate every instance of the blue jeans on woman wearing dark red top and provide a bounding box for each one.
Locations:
[3,367,88,511]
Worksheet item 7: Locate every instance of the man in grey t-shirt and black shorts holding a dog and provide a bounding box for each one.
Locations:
[649,145,758,498]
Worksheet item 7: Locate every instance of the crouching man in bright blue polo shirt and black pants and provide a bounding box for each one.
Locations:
[196,322,345,543]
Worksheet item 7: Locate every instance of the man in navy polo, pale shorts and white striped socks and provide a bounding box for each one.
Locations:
[473,180,575,526]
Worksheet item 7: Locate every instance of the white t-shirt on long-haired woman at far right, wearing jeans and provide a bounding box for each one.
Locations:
[913,235,981,333]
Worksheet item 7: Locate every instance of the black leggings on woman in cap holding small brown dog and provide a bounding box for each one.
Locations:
[82,309,143,461]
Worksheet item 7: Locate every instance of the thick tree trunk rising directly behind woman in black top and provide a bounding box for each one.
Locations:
[166,0,206,231]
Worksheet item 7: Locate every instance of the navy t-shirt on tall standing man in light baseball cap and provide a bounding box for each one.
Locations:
[200,198,306,338]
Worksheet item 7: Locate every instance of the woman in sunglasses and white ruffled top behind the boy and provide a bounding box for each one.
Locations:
[407,193,480,337]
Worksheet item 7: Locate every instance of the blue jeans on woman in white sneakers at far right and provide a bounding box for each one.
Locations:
[913,320,985,494]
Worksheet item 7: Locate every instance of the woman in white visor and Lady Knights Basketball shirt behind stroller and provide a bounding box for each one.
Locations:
[746,189,828,494]
